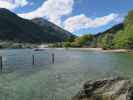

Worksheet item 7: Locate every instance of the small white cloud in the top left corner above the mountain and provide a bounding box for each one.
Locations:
[0,0,28,10]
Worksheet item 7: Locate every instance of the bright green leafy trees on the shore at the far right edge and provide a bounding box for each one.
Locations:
[102,11,133,49]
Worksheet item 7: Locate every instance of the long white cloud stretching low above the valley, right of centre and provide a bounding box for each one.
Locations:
[64,13,118,32]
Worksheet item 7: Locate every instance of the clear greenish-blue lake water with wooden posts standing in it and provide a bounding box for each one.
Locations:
[0,49,133,100]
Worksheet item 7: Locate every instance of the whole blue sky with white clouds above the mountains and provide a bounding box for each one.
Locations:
[0,0,133,36]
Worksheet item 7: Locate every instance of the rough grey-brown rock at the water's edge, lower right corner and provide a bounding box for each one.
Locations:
[72,77,133,100]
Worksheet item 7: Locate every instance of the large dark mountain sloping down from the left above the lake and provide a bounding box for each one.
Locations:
[0,8,72,43]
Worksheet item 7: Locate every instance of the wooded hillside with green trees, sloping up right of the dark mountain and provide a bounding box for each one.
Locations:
[50,11,133,49]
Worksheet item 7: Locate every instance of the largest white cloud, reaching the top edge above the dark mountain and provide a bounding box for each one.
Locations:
[18,0,74,25]
